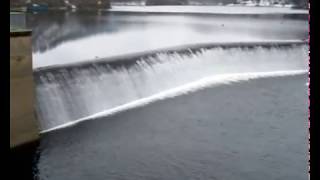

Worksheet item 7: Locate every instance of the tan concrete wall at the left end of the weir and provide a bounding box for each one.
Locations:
[10,30,39,147]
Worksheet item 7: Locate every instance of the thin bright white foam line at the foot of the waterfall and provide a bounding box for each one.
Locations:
[40,70,308,134]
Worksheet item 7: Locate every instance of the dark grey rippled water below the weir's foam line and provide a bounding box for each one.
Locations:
[37,75,308,180]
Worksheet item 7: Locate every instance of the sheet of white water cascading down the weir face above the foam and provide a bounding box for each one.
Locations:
[35,43,308,131]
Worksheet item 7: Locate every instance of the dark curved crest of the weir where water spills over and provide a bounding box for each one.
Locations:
[35,40,307,72]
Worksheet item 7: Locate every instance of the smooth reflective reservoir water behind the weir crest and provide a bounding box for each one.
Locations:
[27,8,308,69]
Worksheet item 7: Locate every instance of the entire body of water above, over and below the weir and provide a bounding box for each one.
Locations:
[27,7,309,180]
